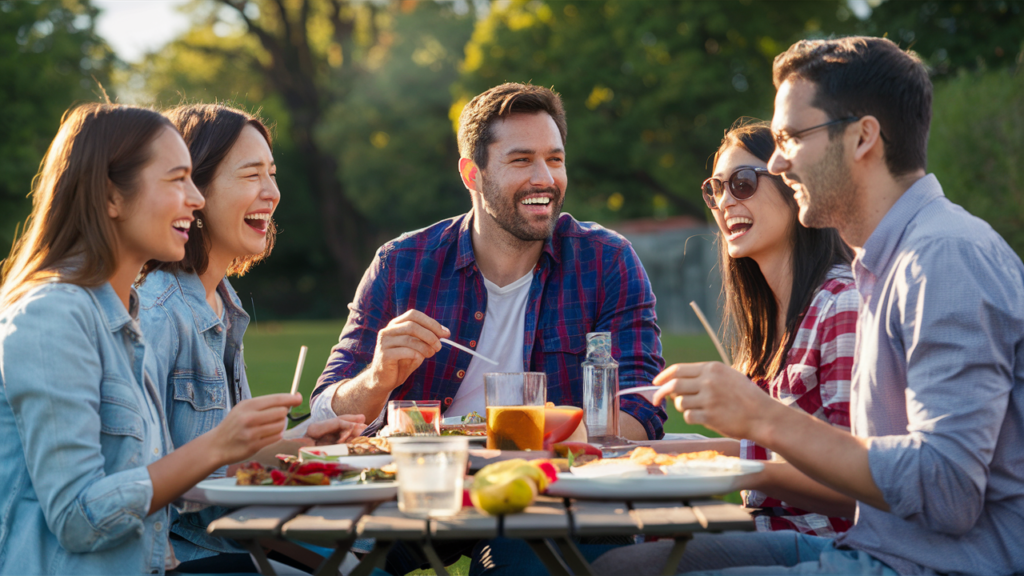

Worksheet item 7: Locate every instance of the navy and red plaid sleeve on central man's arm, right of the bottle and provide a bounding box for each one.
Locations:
[595,240,668,439]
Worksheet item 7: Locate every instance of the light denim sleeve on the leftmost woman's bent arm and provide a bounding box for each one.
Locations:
[3,289,153,552]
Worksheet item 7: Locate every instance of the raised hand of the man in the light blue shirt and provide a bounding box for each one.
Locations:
[653,362,781,439]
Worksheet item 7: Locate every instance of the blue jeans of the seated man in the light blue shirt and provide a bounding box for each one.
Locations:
[594,531,897,576]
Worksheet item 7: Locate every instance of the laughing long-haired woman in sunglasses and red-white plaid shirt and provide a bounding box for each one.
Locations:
[594,119,858,576]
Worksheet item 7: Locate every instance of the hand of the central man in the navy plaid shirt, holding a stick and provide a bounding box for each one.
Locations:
[369,310,452,393]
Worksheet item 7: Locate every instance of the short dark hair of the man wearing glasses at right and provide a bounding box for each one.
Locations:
[773,36,932,176]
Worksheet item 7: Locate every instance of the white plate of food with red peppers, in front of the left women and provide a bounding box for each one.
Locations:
[195,457,398,506]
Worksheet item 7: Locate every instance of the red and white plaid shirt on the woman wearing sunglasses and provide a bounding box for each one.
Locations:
[739,265,860,537]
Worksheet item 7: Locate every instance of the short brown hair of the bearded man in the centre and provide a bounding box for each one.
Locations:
[459,82,567,170]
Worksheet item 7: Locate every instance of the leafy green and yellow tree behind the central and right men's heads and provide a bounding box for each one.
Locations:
[455,0,854,219]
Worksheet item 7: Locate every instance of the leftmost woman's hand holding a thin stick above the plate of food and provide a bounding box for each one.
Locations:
[209,394,302,465]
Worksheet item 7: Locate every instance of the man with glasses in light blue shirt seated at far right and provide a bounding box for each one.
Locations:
[598,38,1024,574]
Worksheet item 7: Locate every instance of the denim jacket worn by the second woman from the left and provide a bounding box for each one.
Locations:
[139,272,252,562]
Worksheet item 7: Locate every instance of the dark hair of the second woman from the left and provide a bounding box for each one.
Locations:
[142,105,278,276]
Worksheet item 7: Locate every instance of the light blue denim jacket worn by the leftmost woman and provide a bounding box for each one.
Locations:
[0,283,170,574]
